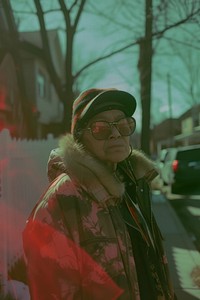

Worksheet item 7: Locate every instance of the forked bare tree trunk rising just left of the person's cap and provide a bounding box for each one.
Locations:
[34,0,86,130]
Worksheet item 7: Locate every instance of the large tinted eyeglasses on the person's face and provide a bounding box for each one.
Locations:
[86,117,136,140]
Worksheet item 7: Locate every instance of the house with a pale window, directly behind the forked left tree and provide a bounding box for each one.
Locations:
[20,30,64,138]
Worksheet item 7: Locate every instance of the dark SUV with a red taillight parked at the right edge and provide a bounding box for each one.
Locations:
[160,145,200,194]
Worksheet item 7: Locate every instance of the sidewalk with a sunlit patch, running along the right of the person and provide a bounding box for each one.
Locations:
[152,191,200,300]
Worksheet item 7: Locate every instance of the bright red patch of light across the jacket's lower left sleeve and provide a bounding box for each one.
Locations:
[23,207,123,300]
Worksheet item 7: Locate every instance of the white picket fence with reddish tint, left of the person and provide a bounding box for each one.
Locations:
[0,130,57,300]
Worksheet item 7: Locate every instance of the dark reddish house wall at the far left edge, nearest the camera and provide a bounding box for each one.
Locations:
[0,2,27,137]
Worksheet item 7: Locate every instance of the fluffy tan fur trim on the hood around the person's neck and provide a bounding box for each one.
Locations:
[48,134,157,200]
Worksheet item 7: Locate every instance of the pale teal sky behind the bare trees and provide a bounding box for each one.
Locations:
[11,0,200,131]
